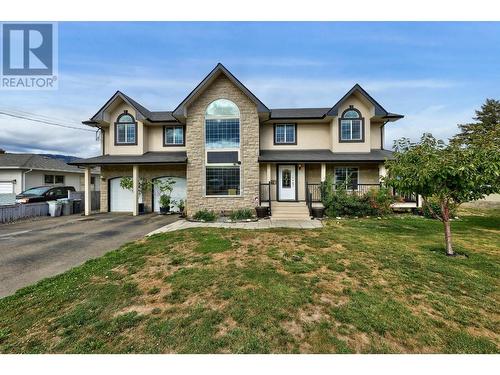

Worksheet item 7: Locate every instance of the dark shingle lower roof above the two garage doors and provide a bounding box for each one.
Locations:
[70,151,187,165]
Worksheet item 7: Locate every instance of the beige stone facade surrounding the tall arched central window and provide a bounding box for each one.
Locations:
[186,75,259,215]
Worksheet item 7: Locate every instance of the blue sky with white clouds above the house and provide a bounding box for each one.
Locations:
[0,22,500,157]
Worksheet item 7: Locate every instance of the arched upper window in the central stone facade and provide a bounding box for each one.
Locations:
[205,99,240,149]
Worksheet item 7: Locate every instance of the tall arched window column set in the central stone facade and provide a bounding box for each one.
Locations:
[205,99,241,196]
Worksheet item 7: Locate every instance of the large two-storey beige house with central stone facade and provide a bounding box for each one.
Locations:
[71,64,403,217]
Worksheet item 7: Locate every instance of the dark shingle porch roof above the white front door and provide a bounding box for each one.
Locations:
[259,150,393,163]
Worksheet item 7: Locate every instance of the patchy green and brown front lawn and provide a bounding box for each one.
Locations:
[0,209,500,353]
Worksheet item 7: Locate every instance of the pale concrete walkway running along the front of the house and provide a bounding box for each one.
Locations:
[147,219,323,236]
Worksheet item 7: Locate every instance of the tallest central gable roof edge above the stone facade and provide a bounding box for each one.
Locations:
[173,63,270,118]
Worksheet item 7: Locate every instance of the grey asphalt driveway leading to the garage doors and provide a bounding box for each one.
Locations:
[0,214,178,297]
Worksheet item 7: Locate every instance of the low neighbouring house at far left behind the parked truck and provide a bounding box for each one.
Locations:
[0,150,100,194]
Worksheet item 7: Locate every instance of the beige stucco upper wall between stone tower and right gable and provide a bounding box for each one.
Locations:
[260,122,332,150]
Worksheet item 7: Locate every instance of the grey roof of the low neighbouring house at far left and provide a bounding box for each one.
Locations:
[0,153,83,173]
